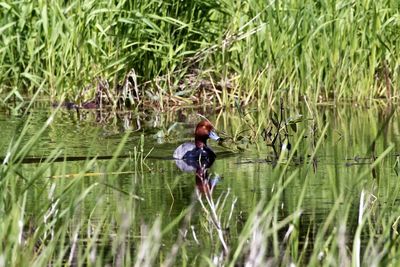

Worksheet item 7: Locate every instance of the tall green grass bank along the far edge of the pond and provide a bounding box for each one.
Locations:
[0,0,400,105]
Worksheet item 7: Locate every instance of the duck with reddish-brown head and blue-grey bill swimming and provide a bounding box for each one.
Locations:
[173,120,220,161]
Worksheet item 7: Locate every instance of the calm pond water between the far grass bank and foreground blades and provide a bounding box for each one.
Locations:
[0,102,400,264]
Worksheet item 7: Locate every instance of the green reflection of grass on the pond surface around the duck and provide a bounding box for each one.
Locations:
[0,103,399,262]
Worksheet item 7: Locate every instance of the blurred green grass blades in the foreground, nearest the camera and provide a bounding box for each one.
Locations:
[0,107,400,266]
